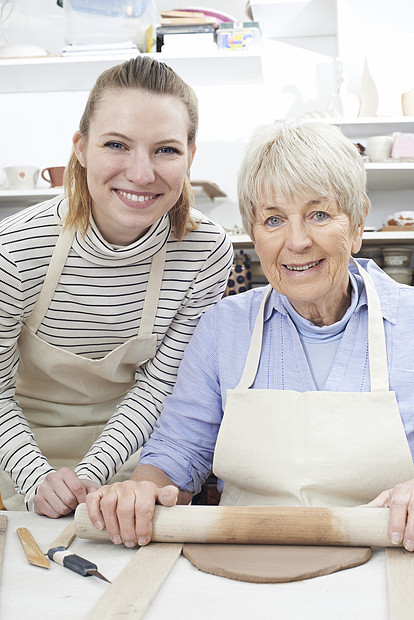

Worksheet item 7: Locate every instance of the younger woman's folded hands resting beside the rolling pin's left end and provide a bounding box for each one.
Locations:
[33,467,100,519]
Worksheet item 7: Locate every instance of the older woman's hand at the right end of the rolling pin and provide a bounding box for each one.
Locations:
[366,479,414,551]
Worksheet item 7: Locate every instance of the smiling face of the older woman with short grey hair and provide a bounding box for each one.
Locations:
[253,197,364,324]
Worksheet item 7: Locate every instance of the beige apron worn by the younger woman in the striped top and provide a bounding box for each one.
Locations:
[0,225,166,509]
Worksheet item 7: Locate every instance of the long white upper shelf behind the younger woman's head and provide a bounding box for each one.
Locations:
[0,50,263,94]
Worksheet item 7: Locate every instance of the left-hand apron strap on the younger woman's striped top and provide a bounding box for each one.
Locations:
[26,228,75,333]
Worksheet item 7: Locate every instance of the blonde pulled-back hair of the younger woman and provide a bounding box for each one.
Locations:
[64,56,198,240]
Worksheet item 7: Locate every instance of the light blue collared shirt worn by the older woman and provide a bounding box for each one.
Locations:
[140,259,414,493]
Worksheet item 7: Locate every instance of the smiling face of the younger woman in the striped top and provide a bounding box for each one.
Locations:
[74,89,195,245]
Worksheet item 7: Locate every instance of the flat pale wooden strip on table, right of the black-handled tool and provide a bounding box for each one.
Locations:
[86,543,182,620]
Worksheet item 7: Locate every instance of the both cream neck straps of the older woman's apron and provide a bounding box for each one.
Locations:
[235,257,389,392]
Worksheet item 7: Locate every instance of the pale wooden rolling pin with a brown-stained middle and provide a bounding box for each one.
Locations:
[75,504,395,547]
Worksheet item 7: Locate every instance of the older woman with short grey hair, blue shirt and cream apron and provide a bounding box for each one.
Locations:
[87,122,414,551]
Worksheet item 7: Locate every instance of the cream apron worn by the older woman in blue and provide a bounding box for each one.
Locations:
[213,266,414,506]
